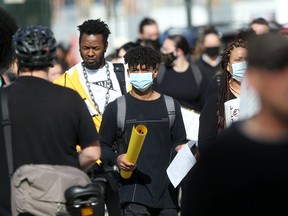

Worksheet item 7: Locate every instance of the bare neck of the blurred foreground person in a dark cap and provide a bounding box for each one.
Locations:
[243,107,288,141]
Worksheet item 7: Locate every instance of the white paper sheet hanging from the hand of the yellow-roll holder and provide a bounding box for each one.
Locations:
[166,141,196,188]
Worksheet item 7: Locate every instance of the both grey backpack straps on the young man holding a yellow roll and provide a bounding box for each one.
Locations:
[116,95,175,140]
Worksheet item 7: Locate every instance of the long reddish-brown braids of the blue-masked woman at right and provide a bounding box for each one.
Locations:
[217,37,248,134]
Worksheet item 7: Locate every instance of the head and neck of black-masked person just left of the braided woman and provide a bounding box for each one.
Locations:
[196,26,222,79]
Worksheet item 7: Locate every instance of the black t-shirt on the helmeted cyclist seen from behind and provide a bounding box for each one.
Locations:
[0,76,98,215]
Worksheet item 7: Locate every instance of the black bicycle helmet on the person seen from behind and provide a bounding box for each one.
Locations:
[12,25,57,67]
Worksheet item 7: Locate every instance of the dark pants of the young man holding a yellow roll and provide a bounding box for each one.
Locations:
[122,203,178,216]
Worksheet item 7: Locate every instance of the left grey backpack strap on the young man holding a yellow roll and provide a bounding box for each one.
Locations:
[116,95,126,138]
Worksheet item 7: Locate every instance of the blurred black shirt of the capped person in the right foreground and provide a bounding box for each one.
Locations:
[190,122,288,216]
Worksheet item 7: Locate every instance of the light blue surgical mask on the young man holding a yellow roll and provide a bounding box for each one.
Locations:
[130,72,153,92]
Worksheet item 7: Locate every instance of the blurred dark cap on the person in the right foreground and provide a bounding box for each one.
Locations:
[248,32,288,70]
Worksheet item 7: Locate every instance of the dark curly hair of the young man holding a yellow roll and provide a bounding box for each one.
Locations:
[124,46,161,70]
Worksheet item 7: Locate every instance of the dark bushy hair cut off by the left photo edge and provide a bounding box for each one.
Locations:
[0,7,18,72]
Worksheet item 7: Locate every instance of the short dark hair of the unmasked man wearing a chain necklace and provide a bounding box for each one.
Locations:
[77,19,111,44]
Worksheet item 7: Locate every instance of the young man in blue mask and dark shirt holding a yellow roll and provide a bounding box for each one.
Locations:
[99,46,187,216]
